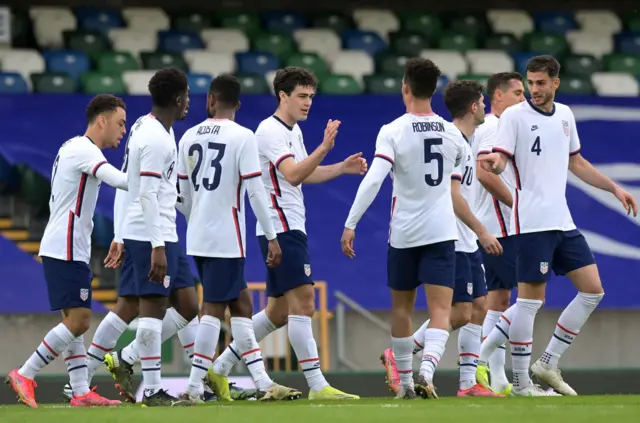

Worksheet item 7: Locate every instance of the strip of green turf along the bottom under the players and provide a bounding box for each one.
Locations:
[0,396,640,423]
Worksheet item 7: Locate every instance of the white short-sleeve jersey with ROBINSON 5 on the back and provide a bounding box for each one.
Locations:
[375,113,466,248]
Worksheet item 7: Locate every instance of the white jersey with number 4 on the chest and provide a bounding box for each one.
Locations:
[493,101,580,235]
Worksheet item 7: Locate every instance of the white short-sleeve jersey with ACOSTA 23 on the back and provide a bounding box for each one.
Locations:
[178,119,262,258]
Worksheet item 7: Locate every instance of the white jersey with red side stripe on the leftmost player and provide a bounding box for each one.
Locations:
[39,136,107,263]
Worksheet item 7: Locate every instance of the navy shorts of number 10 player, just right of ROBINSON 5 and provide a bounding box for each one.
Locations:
[453,250,487,303]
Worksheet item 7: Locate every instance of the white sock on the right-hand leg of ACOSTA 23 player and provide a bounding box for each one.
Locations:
[231,317,273,389]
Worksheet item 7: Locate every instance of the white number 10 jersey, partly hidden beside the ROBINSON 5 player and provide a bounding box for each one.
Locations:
[451,134,480,253]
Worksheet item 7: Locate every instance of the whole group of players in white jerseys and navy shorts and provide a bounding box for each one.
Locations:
[7,56,637,408]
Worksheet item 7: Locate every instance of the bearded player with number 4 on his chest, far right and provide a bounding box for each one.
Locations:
[478,56,638,396]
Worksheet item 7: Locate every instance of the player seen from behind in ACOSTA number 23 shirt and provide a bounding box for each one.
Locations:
[178,75,301,403]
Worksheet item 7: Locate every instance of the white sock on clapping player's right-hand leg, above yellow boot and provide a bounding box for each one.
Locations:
[289,315,329,392]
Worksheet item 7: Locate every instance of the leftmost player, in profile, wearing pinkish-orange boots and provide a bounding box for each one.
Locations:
[7,94,127,408]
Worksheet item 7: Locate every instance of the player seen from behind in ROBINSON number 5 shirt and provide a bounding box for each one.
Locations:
[341,58,467,399]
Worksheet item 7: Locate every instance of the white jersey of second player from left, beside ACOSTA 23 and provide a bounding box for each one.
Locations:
[120,114,178,247]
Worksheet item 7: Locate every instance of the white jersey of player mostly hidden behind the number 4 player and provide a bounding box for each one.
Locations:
[471,115,514,238]
